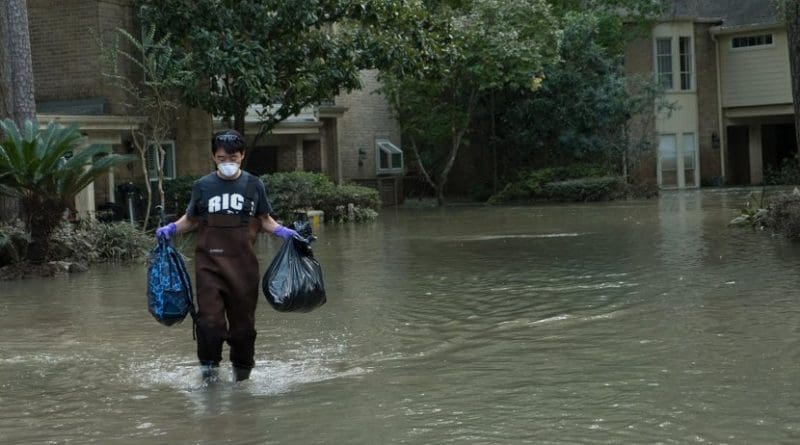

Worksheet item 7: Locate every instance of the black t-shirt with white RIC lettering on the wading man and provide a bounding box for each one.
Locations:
[186,170,272,217]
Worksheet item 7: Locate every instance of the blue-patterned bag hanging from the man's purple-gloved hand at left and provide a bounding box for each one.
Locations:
[147,239,195,326]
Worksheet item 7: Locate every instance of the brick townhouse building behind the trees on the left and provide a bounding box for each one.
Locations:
[13,0,402,214]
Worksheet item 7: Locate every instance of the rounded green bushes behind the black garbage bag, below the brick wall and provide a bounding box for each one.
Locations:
[261,172,381,221]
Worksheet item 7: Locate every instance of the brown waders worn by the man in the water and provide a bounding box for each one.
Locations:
[195,214,260,380]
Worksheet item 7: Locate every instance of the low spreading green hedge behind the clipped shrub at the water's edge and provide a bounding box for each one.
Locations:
[487,164,608,204]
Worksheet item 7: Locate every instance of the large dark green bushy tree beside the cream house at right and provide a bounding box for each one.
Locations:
[495,11,657,173]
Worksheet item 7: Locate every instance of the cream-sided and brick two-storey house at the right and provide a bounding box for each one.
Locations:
[625,0,797,188]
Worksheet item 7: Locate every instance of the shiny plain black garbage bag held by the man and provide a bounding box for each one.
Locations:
[261,221,326,312]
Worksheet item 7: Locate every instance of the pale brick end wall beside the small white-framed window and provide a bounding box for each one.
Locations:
[331,70,400,180]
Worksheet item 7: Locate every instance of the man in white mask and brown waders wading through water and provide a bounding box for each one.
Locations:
[156,130,297,382]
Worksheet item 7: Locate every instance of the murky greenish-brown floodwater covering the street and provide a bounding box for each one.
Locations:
[0,190,800,444]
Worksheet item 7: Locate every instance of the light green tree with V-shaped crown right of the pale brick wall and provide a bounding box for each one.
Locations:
[382,0,559,204]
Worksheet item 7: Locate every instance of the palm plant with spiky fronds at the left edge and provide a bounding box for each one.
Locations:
[0,119,136,263]
